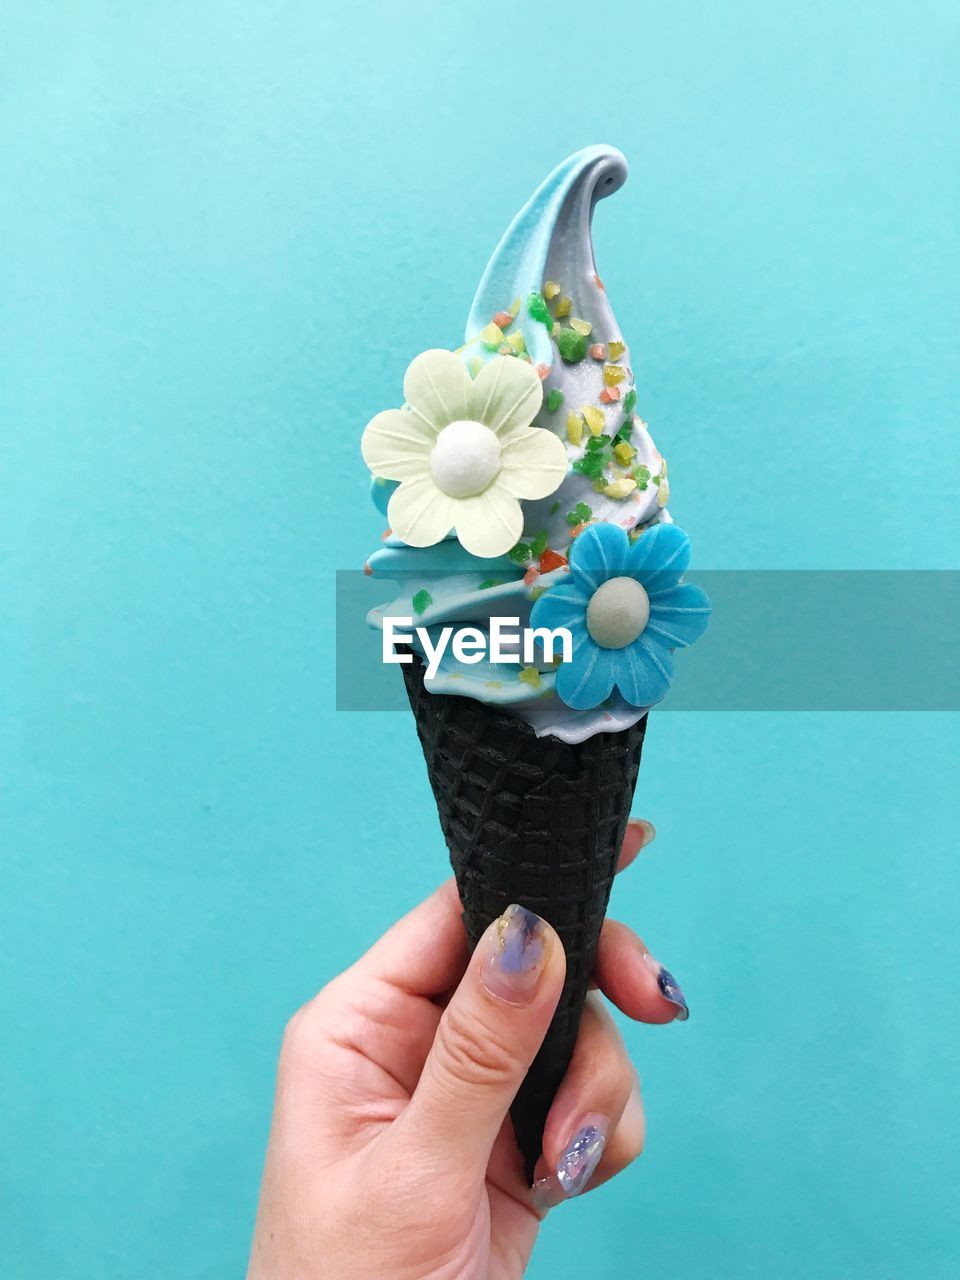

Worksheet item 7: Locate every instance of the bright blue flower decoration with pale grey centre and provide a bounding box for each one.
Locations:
[530,524,710,710]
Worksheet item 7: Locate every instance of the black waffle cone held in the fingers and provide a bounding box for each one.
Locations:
[402,658,646,1181]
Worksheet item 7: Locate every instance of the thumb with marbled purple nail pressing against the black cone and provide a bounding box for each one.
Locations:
[401,905,566,1174]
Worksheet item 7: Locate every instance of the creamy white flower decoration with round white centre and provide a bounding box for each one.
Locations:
[360,351,567,557]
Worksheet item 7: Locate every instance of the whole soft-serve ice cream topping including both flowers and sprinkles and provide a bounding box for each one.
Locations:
[362,147,709,742]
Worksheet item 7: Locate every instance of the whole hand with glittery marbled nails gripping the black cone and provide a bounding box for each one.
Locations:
[248,822,686,1280]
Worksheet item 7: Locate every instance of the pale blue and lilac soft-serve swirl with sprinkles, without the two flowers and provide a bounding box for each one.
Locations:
[366,146,671,742]
